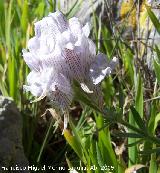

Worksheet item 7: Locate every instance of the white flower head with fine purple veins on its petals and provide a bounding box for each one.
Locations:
[23,11,117,126]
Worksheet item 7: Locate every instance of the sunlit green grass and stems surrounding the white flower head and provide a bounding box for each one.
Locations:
[0,0,160,173]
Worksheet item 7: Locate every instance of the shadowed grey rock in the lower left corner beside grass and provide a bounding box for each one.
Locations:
[0,96,29,173]
